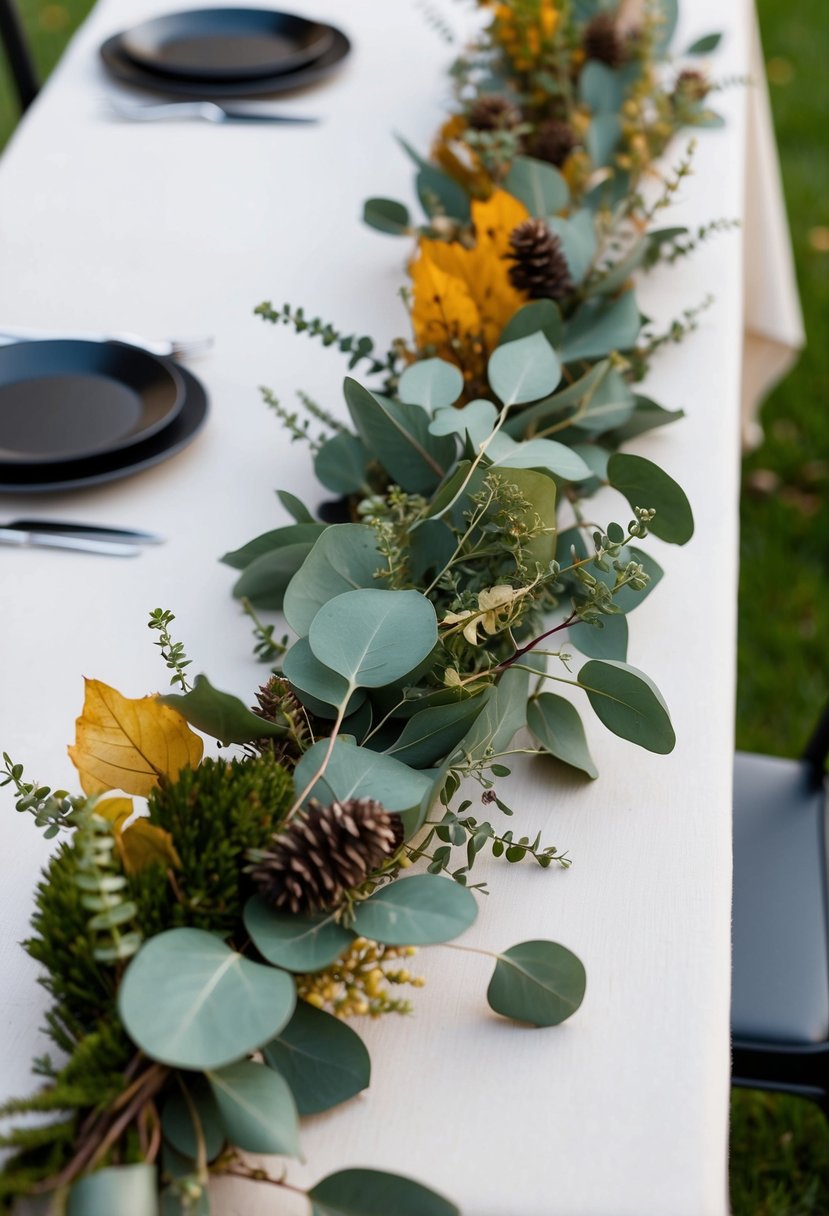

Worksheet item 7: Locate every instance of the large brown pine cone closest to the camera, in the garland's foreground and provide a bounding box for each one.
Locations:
[250,798,404,916]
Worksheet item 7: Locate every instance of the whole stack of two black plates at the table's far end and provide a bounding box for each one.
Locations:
[101,9,350,101]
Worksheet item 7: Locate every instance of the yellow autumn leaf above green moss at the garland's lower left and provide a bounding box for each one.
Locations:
[68,680,203,796]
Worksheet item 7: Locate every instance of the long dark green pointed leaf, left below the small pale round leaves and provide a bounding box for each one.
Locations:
[344,377,455,494]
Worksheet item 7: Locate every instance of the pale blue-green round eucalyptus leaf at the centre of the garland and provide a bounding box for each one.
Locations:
[308,589,438,688]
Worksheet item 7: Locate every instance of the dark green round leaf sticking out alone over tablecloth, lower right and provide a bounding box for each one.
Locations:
[486,941,587,1026]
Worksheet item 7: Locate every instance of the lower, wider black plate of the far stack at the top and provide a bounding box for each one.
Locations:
[101,26,351,101]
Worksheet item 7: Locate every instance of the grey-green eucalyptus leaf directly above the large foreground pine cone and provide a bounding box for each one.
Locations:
[294,739,432,811]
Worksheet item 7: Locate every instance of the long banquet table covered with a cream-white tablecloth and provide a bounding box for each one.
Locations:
[0,0,801,1216]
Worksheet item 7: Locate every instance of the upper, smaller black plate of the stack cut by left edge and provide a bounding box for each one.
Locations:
[0,339,185,466]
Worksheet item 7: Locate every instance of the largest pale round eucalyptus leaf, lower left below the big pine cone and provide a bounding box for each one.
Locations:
[118,929,297,1069]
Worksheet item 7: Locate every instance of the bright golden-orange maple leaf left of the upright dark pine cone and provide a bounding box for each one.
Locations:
[410,190,529,378]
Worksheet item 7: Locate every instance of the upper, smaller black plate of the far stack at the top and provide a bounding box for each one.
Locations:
[120,9,333,80]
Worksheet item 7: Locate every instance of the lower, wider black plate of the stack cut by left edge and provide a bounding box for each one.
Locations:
[0,367,208,494]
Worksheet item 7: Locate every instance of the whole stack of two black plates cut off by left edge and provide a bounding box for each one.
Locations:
[0,339,208,494]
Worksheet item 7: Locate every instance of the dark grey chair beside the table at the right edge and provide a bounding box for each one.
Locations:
[732,709,829,1116]
